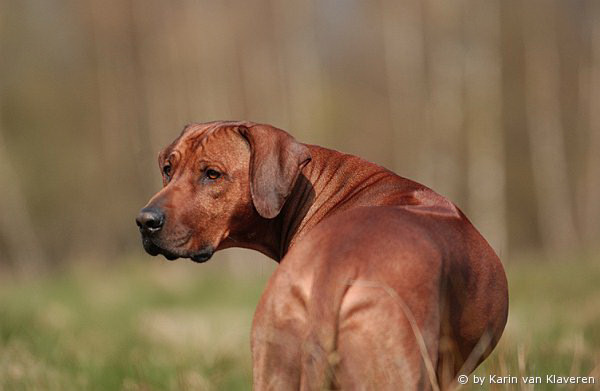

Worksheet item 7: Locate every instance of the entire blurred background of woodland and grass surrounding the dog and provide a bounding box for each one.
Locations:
[0,0,600,389]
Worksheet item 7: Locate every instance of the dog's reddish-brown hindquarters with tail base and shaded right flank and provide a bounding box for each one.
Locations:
[248,206,505,390]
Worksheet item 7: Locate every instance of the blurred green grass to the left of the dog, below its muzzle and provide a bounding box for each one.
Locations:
[0,253,269,390]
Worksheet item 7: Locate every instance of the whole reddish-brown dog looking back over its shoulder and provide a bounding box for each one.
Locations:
[137,122,508,390]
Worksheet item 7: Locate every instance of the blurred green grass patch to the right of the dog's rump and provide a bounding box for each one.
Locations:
[463,257,600,390]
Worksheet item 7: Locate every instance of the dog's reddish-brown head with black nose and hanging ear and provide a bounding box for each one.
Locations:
[136,122,310,262]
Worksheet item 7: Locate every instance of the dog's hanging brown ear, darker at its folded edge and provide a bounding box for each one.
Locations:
[238,125,310,219]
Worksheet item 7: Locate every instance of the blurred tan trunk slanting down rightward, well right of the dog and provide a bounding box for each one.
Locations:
[523,0,577,251]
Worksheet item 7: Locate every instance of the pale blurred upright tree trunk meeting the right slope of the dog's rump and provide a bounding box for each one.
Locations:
[465,0,507,254]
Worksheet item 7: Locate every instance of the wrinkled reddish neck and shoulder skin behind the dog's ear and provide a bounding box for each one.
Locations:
[219,145,429,262]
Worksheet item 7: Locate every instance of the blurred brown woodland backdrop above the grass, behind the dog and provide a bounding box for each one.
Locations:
[0,0,600,262]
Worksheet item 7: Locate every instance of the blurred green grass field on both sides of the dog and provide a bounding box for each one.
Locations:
[0,253,600,390]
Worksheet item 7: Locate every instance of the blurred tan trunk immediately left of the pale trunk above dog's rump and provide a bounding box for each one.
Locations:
[421,0,465,204]
